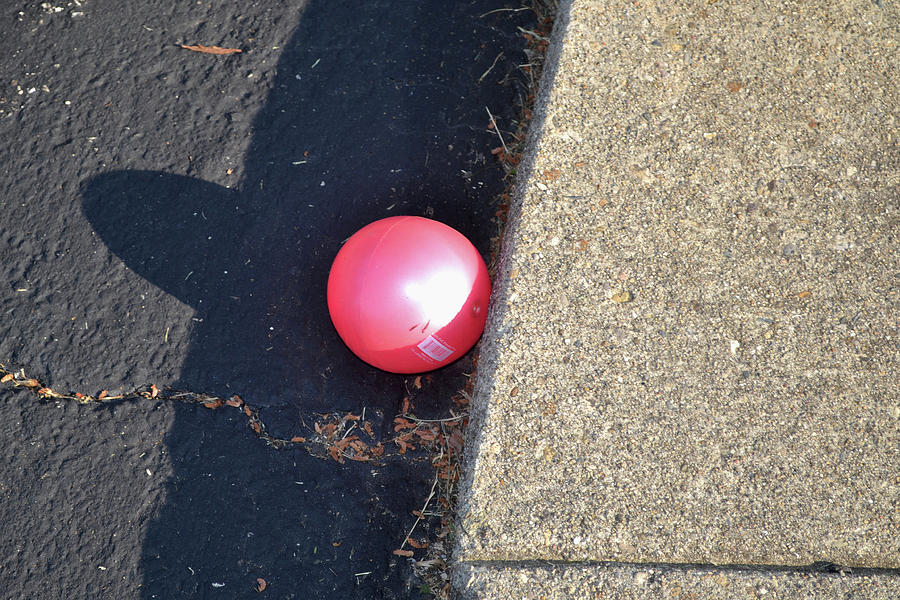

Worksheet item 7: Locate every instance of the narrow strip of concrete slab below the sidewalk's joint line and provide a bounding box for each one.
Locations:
[453,565,900,600]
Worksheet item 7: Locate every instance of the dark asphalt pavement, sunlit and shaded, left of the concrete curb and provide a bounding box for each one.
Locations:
[0,0,534,599]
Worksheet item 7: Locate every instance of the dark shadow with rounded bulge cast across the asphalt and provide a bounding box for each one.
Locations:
[82,1,530,598]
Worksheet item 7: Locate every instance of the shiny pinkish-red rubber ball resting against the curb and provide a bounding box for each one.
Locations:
[328,217,491,373]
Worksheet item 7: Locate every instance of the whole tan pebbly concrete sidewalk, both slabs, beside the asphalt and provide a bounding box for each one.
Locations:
[453,0,900,599]
